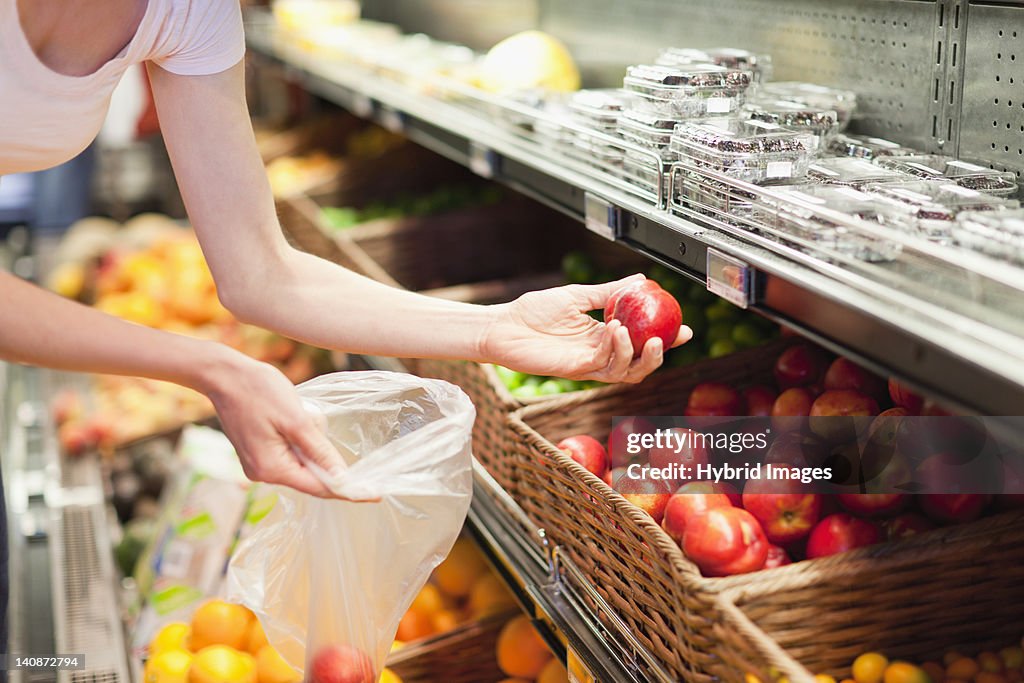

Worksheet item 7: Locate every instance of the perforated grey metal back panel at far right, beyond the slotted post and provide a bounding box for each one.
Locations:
[959,4,1024,177]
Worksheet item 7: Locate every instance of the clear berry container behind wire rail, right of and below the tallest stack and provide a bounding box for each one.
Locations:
[670,119,817,183]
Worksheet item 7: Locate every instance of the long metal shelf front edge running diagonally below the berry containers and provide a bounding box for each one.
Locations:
[241,13,1024,415]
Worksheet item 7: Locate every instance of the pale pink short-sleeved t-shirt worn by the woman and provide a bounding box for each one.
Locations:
[0,0,245,175]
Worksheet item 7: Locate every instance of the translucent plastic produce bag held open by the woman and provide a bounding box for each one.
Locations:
[227,372,475,683]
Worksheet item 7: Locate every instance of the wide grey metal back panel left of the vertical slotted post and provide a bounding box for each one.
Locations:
[541,0,942,147]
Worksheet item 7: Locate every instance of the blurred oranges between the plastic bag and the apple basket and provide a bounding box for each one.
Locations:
[395,539,516,646]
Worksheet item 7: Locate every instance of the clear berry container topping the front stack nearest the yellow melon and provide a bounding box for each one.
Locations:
[623,63,752,120]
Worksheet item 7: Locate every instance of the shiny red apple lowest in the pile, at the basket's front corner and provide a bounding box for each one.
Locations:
[682,507,768,577]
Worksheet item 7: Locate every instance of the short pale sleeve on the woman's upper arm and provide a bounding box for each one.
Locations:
[151,0,246,76]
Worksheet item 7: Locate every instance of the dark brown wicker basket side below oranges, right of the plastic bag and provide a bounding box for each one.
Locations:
[387,612,516,683]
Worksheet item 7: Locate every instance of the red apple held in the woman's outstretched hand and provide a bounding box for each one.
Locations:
[604,280,683,358]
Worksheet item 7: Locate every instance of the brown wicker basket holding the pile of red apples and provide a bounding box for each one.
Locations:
[507,341,1024,681]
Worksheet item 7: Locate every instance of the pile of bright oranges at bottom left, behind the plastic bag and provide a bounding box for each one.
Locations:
[142,600,401,683]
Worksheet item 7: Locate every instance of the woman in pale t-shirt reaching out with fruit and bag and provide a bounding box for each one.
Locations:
[0,0,690,496]
